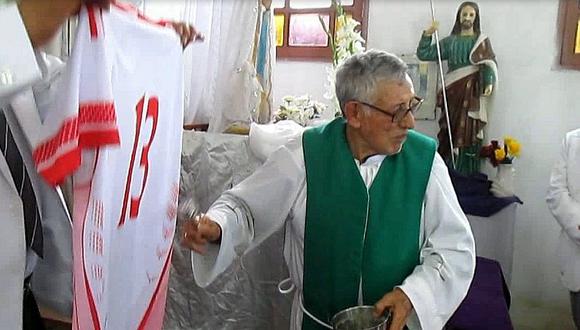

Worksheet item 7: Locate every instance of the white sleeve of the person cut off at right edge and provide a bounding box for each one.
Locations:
[546,136,580,245]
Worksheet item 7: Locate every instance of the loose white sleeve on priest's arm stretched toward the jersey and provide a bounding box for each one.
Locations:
[191,139,305,287]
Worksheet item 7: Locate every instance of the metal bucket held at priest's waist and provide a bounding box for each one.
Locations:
[330,306,389,330]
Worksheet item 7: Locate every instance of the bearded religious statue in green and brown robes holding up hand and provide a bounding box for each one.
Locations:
[417,2,497,174]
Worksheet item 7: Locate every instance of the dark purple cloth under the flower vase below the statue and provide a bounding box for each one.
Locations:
[449,168,523,217]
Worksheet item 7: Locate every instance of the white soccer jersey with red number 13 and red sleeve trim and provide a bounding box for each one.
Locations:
[34,3,183,330]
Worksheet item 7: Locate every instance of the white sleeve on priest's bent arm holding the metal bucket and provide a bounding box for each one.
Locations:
[400,154,475,329]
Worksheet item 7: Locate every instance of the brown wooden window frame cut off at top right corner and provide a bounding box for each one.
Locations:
[560,0,580,70]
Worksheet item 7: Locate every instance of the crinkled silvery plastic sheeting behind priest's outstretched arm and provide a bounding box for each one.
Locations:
[164,132,292,330]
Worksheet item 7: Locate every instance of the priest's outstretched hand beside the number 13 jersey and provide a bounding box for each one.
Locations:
[181,214,222,254]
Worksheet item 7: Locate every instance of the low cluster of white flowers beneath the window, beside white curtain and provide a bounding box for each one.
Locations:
[274,95,326,126]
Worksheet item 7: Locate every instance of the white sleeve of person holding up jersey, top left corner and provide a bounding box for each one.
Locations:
[0,3,40,106]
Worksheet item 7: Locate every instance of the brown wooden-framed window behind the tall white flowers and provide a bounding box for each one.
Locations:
[272,0,368,61]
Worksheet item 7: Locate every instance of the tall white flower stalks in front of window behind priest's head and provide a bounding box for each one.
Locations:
[318,0,365,116]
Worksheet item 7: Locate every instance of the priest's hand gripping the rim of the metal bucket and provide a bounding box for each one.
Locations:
[375,288,413,330]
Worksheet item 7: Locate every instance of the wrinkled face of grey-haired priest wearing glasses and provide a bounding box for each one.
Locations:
[358,75,420,155]
